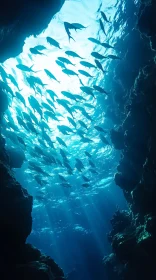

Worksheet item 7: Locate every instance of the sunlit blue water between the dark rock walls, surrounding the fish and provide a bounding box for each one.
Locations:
[0,0,139,280]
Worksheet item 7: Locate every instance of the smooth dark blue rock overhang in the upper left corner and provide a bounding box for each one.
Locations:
[0,0,64,62]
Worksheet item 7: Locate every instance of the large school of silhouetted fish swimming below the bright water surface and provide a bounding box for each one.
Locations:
[0,9,121,200]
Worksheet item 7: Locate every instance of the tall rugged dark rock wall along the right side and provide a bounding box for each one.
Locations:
[104,0,156,280]
